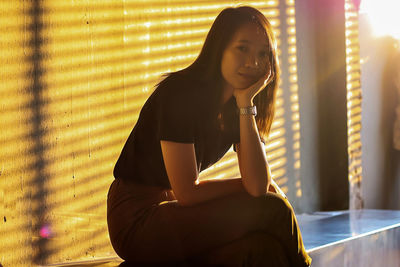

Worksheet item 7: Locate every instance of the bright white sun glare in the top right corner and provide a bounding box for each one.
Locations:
[360,0,400,40]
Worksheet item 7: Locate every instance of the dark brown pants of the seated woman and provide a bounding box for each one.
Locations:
[107,179,311,266]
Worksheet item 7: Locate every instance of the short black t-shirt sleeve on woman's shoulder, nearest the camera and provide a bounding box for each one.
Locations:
[158,88,196,143]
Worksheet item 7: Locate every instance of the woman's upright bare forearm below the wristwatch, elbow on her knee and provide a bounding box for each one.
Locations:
[238,115,271,196]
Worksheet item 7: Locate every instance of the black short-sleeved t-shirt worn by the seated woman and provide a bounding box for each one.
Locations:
[114,74,240,189]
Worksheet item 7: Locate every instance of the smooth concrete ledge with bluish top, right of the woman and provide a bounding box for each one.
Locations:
[298,210,400,267]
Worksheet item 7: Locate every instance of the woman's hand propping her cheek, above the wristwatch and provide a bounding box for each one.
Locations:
[233,69,272,108]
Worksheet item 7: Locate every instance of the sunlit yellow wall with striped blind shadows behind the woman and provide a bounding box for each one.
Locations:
[0,0,302,266]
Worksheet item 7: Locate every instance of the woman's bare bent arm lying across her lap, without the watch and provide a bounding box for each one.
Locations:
[161,141,245,206]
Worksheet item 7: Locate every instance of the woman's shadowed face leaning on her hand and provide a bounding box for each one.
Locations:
[221,23,270,90]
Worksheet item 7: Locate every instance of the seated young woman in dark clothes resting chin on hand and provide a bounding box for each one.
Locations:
[107,7,311,266]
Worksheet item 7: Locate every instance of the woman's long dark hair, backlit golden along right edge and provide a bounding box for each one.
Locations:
[161,6,280,138]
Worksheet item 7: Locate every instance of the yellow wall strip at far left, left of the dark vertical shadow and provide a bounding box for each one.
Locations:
[0,1,38,266]
